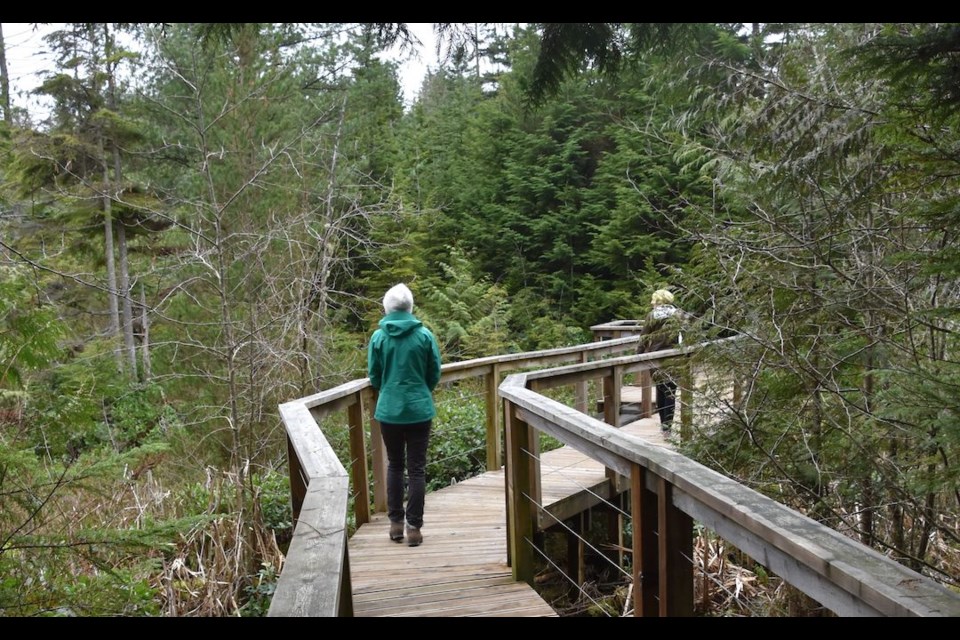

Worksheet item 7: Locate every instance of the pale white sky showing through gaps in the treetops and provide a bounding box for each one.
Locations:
[2,22,437,120]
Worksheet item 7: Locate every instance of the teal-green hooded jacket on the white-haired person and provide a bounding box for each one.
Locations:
[367,311,440,424]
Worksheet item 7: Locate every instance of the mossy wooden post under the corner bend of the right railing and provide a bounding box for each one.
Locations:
[503,400,535,586]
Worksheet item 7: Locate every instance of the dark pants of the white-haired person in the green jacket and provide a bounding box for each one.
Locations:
[380,420,433,528]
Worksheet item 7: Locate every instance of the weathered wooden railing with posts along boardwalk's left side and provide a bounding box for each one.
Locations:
[268,337,636,616]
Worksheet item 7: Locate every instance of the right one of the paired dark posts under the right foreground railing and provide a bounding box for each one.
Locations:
[657,478,693,617]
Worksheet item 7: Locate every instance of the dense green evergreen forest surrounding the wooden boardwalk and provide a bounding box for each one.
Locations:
[0,23,960,617]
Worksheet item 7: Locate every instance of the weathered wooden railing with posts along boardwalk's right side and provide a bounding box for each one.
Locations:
[499,348,960,617]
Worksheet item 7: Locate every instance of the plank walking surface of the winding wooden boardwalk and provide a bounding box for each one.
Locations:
[349,408,669,617]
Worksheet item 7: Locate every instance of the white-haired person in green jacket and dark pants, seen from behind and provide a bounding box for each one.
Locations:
[367,284,440,547]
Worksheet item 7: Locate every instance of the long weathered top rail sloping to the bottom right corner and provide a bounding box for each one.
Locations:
[500,374,960,616]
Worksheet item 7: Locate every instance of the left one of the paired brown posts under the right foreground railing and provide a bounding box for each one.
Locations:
[630,464,660,617]
